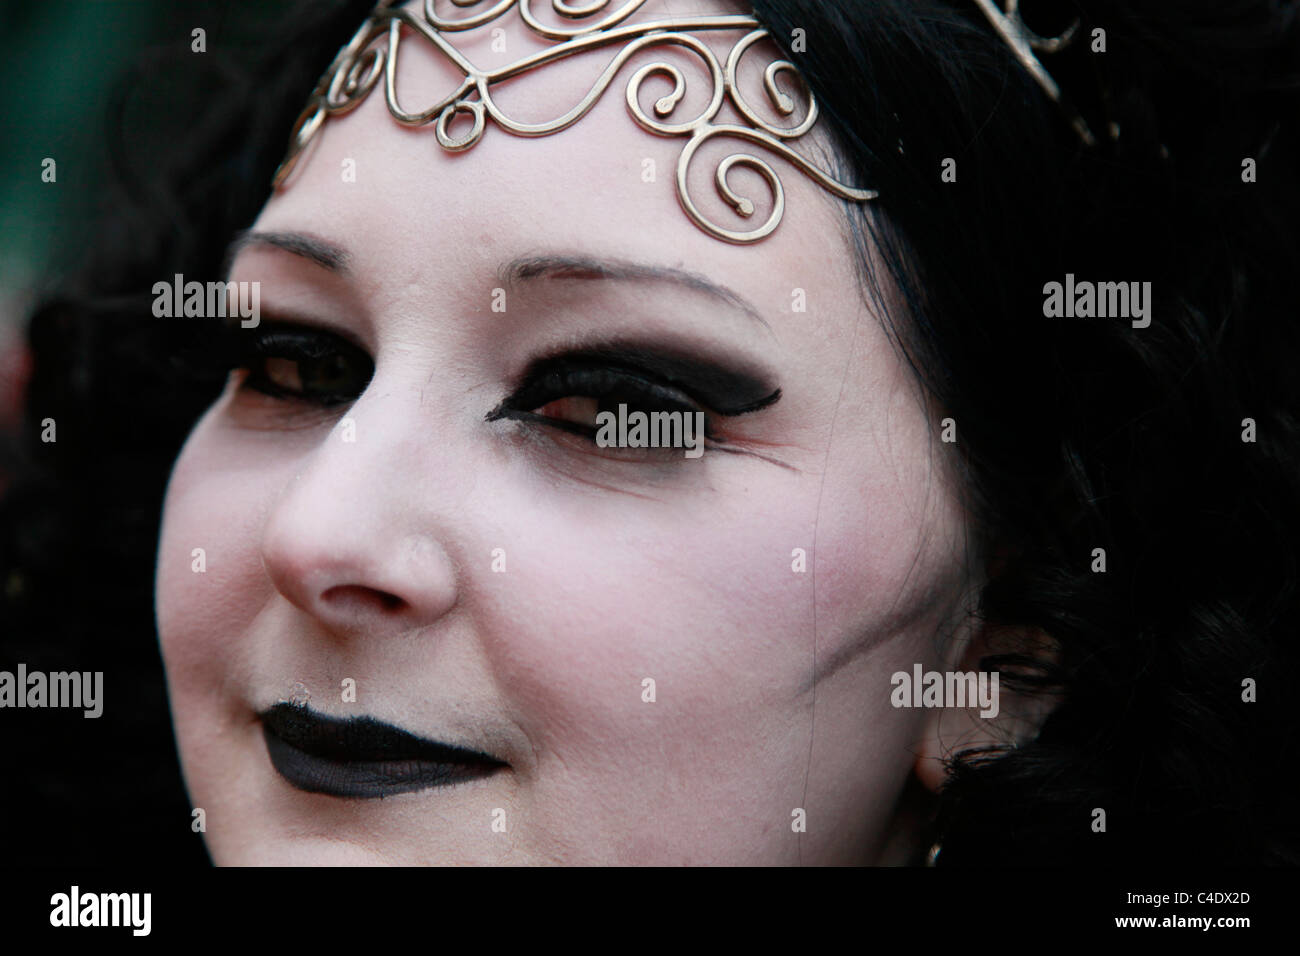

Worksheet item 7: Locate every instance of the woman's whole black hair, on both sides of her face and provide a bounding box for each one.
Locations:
[0,0,1300,865]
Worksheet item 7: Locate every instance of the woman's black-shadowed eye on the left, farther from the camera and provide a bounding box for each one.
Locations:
[233,325,374,407]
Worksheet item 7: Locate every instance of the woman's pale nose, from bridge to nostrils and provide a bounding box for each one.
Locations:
[261,406,458,637]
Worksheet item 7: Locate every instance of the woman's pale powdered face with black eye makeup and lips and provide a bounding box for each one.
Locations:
[157,3,970,864]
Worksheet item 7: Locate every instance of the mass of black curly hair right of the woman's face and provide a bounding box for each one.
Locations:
[753,0,1300,865]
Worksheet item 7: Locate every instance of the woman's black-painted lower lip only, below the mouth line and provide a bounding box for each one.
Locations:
[263,727,502,800]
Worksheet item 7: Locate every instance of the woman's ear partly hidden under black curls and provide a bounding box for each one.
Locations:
[915,624,1060,793]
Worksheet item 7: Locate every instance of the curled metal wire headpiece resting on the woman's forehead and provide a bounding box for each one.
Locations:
[273,0,878,245]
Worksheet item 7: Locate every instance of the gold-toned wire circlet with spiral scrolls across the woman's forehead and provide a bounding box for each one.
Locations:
[273,0,879,245]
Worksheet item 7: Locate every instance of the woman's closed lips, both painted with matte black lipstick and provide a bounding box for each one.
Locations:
[261,704,508,799]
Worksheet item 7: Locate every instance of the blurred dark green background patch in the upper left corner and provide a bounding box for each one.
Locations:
[0,0,306,428]
